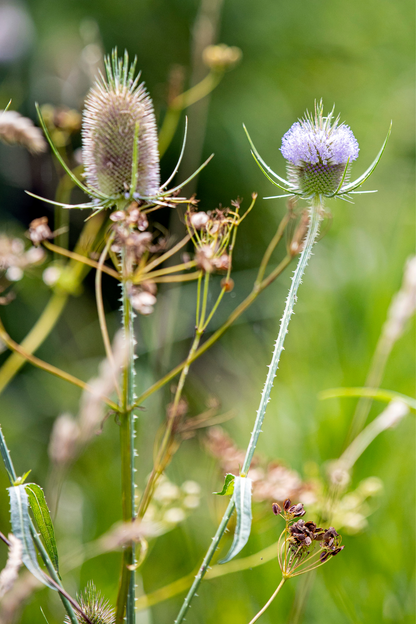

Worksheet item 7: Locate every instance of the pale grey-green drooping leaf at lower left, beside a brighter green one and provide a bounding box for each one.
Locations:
[8,485,56,590]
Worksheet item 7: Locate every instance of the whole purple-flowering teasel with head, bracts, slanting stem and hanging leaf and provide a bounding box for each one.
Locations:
[175,100,391,624]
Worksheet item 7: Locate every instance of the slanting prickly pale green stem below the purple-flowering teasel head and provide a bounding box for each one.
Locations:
[175,197,323,624]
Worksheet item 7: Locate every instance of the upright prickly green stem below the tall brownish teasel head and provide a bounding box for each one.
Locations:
[116,250,136,624]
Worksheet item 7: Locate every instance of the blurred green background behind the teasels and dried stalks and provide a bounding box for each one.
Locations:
[0,0,415,624]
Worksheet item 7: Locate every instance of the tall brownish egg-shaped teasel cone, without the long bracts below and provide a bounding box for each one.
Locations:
[82,51,160,199]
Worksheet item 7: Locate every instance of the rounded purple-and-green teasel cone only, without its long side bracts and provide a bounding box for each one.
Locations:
[280,101,359,197]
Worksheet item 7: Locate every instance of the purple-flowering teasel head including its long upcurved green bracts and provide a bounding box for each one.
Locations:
[242,100,391,202]
